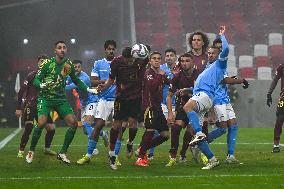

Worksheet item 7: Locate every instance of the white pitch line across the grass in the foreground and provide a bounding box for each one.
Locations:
[0,174,284,180]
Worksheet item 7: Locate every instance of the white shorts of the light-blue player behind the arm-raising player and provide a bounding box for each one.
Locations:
[214,103,236,122]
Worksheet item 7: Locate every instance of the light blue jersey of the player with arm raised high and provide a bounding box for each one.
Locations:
[193,35,229,100]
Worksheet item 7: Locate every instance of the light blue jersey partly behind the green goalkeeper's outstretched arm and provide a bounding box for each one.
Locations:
[65,71,99,107]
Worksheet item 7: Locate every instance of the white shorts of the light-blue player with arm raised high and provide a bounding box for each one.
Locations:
[190,92,213,125]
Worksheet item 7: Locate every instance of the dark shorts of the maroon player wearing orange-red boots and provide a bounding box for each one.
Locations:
[144,108,169,132]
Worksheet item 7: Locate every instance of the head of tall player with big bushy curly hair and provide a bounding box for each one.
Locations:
[188,31,209,52]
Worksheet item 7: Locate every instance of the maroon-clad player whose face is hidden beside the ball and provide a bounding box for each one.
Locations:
[100,45,148,170]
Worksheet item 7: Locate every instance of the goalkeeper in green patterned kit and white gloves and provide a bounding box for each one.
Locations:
[26,41,97,164]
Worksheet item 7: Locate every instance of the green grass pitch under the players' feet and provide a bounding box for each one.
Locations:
[0,128,284,189]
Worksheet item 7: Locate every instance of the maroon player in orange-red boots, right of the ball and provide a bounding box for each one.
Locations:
[135,51,169,167]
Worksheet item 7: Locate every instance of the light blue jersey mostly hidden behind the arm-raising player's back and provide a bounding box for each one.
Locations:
[213,73,230,105]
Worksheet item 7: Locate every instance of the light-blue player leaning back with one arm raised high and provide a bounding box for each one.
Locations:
[183,26,229,169]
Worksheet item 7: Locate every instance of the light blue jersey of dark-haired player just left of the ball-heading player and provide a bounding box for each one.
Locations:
[91,58,116,101]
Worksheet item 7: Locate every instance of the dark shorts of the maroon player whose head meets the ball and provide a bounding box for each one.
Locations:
[113,98,141,120]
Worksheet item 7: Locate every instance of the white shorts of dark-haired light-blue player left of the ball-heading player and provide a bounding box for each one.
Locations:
[95,99,114,121]
